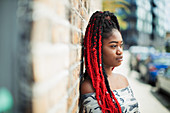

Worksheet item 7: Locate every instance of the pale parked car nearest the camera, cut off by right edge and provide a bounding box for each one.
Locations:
[156,67,170,95]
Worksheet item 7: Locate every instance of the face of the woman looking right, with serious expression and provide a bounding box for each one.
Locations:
[103,29,123,67]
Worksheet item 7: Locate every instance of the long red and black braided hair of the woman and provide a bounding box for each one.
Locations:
[81,11,121,113]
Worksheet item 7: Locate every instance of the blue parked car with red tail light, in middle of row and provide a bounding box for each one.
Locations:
[139,53,170,85]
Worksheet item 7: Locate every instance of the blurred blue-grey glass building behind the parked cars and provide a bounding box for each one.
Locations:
[120,0,166,49]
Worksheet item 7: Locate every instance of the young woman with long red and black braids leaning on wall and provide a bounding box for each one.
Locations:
[79,11,139,113]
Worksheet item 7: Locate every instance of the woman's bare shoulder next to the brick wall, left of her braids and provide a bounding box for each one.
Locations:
[80,79,95,95]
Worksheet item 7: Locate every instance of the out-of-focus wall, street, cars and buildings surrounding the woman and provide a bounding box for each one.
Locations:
[0,0,170,113]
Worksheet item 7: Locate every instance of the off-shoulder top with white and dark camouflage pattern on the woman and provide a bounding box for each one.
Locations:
[81,86,140,113]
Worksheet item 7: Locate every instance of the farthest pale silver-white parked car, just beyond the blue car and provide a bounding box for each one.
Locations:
[129,46,156,72]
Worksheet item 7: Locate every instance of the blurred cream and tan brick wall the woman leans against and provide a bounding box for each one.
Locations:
[31,0,101,113]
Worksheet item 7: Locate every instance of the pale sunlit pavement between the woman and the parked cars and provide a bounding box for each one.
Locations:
[113,51,170,113]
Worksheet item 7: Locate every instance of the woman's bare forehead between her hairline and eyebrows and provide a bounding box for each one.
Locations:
[103,30,123,43]
